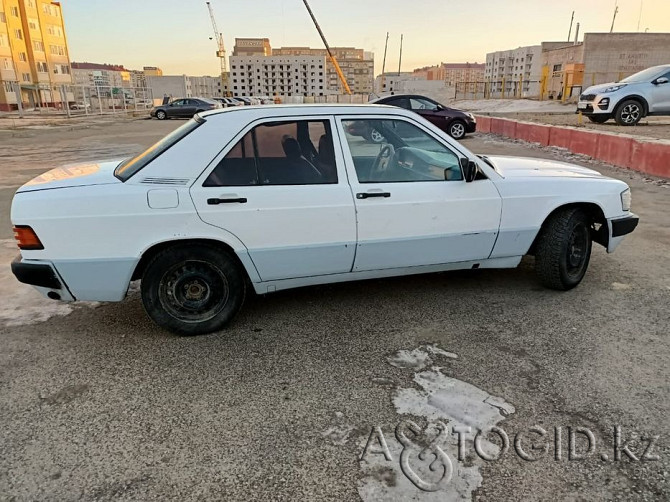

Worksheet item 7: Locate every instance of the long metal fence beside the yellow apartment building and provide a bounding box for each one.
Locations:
[4,84,154,117]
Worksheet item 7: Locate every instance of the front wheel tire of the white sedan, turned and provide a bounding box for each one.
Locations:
[535,208,592,291]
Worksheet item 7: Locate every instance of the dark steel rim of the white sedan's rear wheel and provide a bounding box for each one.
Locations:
[158,260,230,322]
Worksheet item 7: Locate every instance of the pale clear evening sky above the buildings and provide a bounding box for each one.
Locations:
[61,0,670,75]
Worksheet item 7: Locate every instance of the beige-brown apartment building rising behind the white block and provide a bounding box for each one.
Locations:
[272,47,375,94]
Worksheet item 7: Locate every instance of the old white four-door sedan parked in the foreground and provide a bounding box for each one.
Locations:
[11,105,638,335]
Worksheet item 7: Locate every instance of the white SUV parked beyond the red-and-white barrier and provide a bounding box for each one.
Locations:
[577,64,670,126]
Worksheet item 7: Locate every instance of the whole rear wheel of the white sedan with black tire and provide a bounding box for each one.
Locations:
[141,244,246,336]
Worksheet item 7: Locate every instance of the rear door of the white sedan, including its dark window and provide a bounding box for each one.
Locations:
[191,116,356,281]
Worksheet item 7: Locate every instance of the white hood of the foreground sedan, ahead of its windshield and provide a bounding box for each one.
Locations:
[487,156,604,178]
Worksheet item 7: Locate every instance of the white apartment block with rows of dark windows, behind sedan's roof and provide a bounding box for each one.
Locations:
[229,55,330,96]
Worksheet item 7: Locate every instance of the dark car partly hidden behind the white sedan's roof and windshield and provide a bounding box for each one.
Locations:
[370,94,477,141]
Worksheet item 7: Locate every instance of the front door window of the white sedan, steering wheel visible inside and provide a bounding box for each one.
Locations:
[342,119,463,183]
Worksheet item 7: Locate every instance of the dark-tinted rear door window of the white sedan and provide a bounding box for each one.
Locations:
[203,120,337,187]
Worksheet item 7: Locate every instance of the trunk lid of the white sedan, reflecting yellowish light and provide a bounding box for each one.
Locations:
[17,159,123,193]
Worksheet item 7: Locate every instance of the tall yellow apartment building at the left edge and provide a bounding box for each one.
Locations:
[0,0,73,111]
